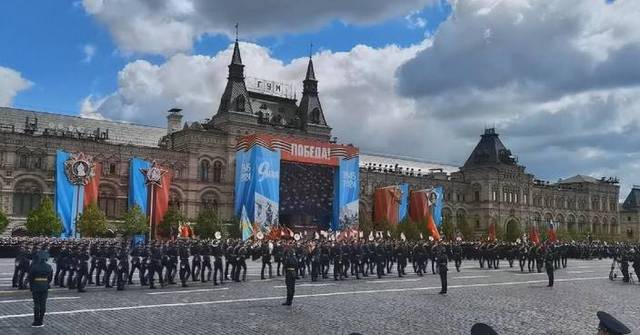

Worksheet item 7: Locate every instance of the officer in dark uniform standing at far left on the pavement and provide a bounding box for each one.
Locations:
[29,251,53,327]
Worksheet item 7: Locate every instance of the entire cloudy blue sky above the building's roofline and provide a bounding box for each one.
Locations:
[0,0,640,197]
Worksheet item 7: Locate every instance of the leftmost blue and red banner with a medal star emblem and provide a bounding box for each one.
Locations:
[55,150,100,238]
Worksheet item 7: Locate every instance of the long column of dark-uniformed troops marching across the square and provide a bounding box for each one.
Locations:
[0,238,640,292]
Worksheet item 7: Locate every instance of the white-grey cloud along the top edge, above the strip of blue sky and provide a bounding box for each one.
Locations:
[83,0,437,55]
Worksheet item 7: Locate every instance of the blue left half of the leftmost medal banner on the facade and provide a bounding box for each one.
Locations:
[55,150,79,238]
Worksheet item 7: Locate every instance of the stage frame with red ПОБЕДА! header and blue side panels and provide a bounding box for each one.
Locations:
[234,134,360,237]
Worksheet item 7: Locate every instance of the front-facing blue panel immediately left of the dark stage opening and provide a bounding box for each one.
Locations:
[251,145,280,232]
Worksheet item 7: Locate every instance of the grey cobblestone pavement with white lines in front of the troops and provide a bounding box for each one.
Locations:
[0,259,640,335]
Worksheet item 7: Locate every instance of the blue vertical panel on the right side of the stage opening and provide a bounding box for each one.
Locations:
[331,156,360,231]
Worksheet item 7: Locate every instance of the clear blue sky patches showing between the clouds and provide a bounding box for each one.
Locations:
[0,0,451,114]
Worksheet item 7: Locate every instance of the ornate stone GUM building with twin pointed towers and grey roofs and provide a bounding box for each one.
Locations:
[0,42,640,239]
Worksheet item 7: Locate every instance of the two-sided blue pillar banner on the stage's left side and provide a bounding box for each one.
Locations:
[234,145,280,239]
